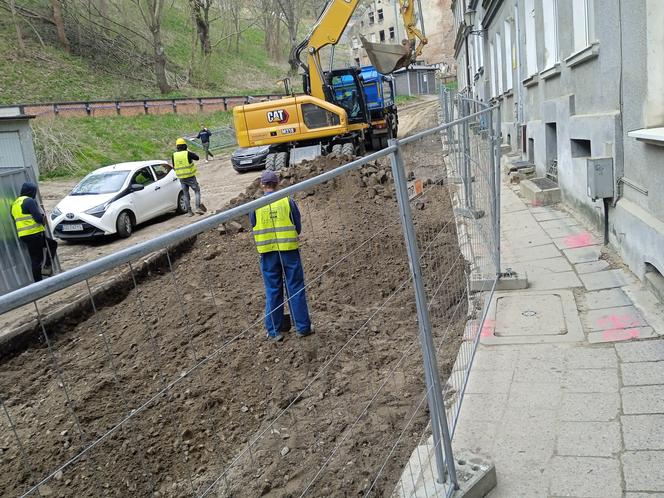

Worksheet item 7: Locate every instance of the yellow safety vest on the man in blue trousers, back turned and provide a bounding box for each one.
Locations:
[253,197,299,254]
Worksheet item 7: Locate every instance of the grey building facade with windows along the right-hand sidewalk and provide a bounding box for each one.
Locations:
[452,0,664,284]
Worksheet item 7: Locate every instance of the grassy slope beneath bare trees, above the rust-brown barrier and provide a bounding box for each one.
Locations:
[0,1,298,104]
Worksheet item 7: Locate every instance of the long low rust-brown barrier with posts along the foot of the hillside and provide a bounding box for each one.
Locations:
[0,94,285,118]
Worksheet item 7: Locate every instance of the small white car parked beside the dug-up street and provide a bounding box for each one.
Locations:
[51,161,185,240]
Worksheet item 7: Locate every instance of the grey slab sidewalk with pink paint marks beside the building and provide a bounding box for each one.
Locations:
[454,181,664,498]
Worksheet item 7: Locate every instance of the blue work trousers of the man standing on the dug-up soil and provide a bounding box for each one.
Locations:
[261,249,311,337]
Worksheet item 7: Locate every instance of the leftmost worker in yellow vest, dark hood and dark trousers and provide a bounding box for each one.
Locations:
[12,182,58,282]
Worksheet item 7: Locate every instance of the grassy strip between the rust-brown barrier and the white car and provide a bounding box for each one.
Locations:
[32,111,232,178]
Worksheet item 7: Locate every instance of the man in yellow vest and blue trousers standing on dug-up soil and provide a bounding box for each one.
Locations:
[250,170,313,342]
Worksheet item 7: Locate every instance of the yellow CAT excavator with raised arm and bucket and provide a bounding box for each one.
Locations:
[232,0,427,171]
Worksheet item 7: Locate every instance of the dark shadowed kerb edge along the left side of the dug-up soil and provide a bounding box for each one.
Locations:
[0,236,197,359]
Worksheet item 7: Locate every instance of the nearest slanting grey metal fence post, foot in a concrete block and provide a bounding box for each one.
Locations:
[388,139,458,489]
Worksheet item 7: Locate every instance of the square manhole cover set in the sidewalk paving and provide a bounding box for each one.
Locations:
[495,294,567,337]
